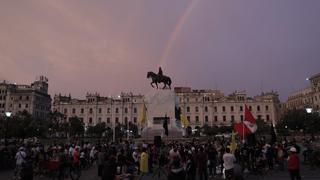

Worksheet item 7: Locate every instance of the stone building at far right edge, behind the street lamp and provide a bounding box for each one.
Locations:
[283,73,320,112]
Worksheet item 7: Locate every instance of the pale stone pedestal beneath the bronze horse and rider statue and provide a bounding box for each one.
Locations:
[141,89,183,140]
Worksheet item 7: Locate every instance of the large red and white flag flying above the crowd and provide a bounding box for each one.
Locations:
[234,105,258,137]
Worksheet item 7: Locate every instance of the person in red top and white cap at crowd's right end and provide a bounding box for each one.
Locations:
[288,147,301,180]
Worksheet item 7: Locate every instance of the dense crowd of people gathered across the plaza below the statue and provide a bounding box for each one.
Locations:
[0,138,312,180]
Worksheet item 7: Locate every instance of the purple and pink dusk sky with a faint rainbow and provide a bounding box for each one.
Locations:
[0,0,320,100]
